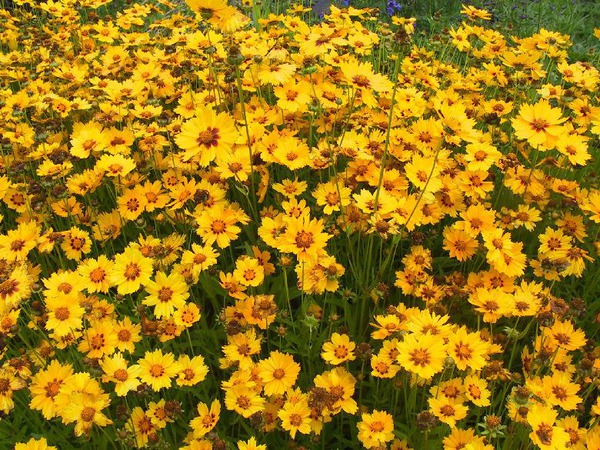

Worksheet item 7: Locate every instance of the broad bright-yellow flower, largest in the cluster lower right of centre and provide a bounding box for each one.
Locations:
[397,334,446,378]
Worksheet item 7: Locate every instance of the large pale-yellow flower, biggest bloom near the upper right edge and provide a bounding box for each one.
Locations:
[512,100,567,150]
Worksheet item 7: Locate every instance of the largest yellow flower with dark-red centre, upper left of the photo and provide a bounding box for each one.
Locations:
[175,107,239,167]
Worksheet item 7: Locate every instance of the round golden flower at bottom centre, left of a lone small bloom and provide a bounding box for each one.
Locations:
[258,351,300,395]
